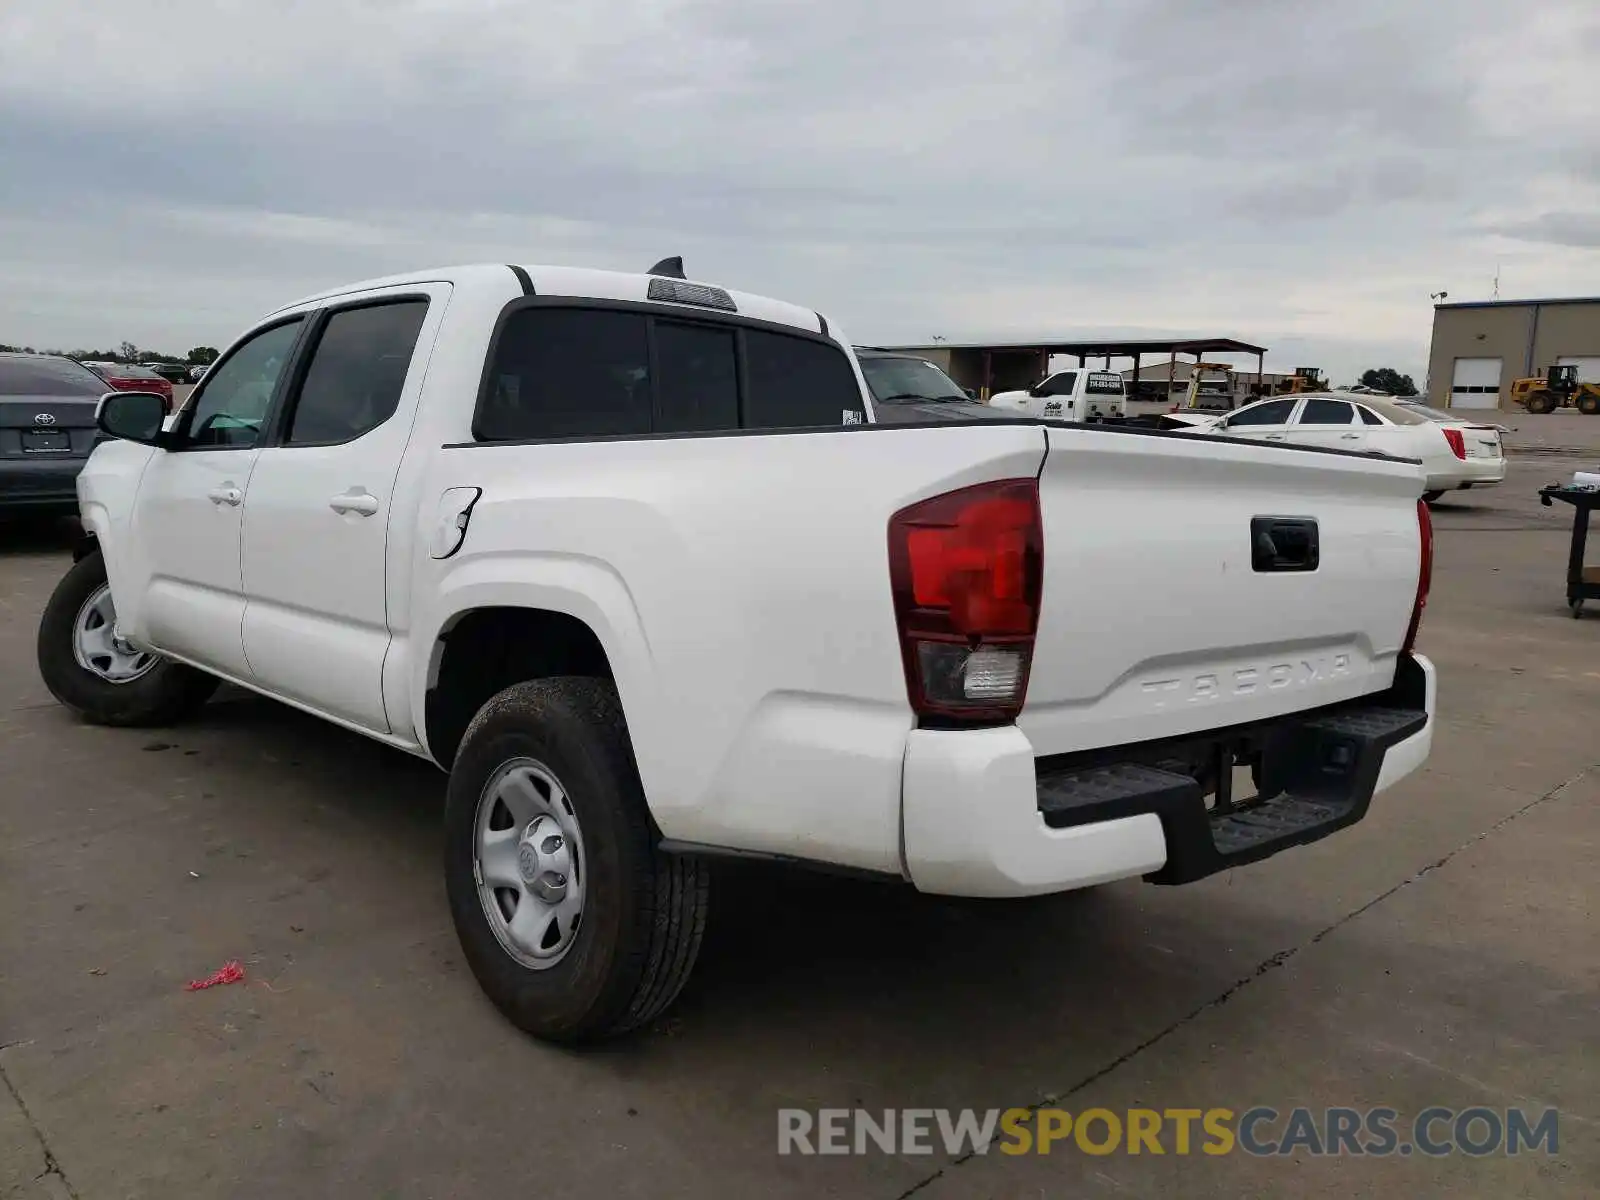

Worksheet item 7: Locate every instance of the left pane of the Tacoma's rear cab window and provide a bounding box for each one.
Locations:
[474,309,651,442]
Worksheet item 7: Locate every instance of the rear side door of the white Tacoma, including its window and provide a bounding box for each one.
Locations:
[233,285,448,733]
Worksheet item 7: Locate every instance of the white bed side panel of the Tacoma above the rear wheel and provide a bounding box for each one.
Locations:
[411,426,1045,872]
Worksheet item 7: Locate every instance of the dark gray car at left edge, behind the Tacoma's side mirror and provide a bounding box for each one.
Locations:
[0,354,110,514]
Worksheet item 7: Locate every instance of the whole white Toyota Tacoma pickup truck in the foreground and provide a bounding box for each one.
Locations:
[38,264,1435,1042]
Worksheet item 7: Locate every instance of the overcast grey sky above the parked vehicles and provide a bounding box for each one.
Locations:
[0,0,1600,384]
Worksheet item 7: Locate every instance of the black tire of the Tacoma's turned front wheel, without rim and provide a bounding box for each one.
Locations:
[37,550,221,726]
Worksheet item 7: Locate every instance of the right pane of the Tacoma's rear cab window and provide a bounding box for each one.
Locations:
[744,330,867,429]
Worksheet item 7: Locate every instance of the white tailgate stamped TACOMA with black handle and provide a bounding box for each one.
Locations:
[1018,427,1422,754]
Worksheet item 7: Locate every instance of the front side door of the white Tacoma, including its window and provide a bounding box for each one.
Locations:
[117,317,302,677]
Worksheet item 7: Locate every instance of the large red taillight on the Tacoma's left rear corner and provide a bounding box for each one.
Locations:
[890,478,1045,723]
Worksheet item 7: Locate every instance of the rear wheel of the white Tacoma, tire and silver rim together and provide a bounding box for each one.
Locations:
[445,677,709,1043]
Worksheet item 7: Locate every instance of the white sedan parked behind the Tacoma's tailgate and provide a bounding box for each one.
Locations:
[1196,392,1506,504]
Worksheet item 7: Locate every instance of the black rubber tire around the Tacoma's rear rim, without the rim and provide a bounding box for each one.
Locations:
[445,677,710,1043]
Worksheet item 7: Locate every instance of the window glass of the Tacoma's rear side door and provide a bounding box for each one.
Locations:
[285,299,427,446]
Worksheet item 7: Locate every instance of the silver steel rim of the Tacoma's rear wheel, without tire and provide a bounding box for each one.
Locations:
[472,758,584,971]
